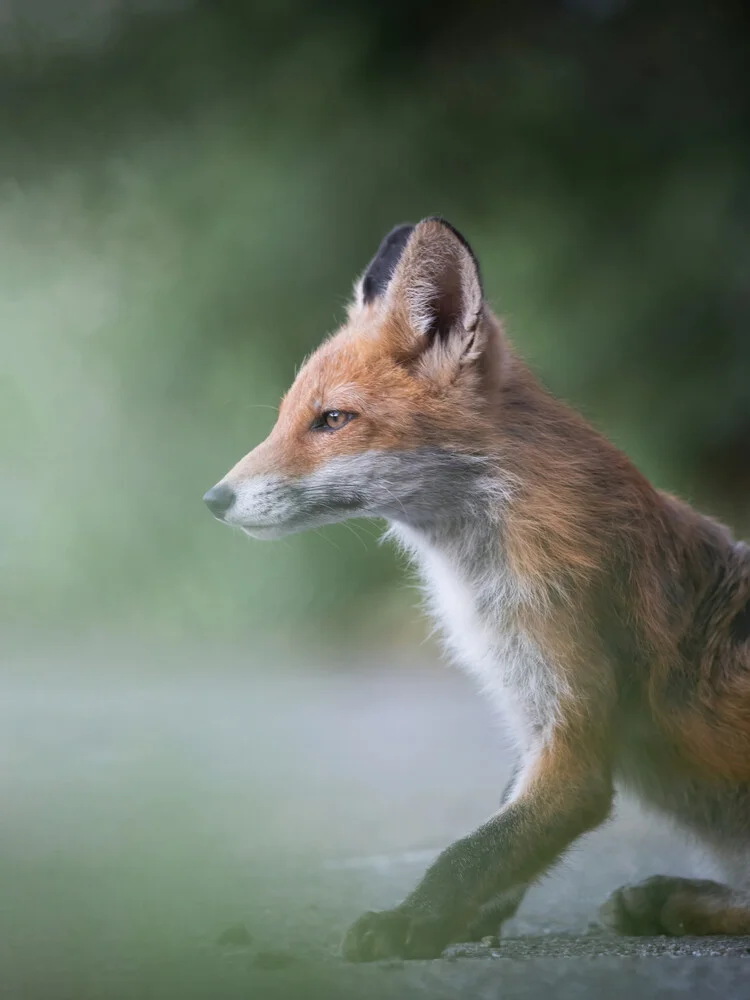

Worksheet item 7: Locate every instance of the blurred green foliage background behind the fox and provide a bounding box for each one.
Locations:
[0,0,750,640]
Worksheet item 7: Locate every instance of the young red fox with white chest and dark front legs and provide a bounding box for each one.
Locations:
[204,216,750,961]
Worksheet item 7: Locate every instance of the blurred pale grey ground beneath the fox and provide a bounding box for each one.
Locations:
[0,647,750,1000]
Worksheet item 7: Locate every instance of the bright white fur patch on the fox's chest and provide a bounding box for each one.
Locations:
[391,525,563,749]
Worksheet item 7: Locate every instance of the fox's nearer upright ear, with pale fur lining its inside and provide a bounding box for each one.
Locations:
[385,217,484,357]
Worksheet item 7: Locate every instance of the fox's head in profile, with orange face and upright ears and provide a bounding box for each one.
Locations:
[204,218,503,538]
